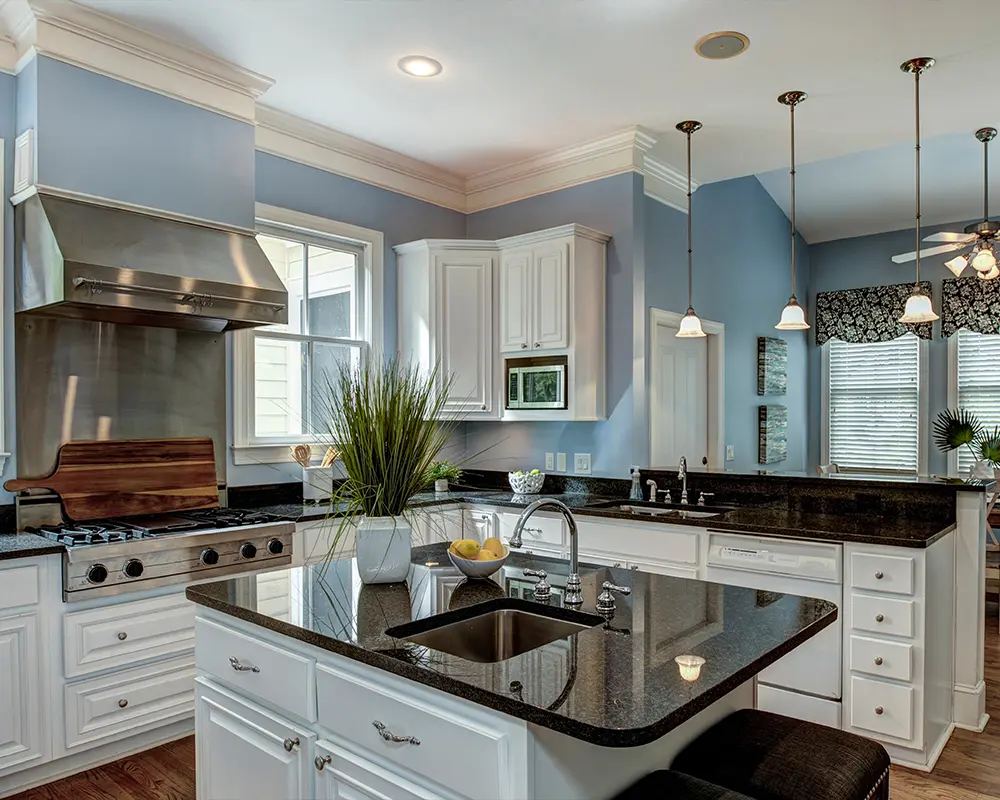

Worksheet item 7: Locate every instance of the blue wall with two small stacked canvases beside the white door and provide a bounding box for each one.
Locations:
[644,176,810,472]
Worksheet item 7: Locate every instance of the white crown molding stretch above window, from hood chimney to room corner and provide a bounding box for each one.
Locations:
[256,105,466,212]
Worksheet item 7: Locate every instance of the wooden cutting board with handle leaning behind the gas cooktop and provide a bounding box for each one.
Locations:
[4,437,219,522]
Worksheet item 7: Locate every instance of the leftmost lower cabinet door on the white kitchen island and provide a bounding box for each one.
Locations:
[195,676,315,800]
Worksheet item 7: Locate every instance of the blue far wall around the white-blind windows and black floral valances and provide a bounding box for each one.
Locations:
[809,222,969,475]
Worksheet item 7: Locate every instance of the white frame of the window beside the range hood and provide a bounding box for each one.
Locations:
[232,203,385,466]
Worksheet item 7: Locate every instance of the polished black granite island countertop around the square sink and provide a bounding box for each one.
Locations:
[187,544,837,747]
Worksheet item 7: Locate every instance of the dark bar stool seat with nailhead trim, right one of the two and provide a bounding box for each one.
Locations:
[672,709,889,800]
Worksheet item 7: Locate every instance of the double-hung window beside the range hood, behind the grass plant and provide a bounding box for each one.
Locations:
[233,209,381,464]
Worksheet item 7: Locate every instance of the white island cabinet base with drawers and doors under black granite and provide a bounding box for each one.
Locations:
[195,609,754,800]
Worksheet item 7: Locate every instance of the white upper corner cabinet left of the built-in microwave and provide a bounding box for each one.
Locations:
[395,240,501,419]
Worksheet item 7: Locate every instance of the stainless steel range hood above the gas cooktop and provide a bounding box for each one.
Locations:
[14,191,288,331]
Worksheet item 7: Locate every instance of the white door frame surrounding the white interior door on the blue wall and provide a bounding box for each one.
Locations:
[648,307,726,470]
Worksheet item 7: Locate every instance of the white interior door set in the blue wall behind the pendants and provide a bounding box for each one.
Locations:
[649,324,708,469]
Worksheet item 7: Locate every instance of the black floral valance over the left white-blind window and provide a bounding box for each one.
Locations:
[816,281,932,345]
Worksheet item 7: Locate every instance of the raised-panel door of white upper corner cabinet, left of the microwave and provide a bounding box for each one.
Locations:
[437,254,496,416]
